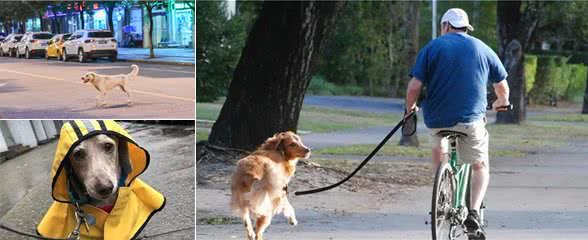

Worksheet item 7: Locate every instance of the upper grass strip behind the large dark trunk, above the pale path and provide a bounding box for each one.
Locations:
[196,103,400,132]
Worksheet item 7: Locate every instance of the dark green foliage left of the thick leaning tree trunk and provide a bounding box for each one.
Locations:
[196,1,258,102]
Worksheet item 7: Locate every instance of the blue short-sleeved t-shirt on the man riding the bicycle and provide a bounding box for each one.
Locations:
[410,33,507,128]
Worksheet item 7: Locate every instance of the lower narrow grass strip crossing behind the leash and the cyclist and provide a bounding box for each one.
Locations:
[314,144,527,158]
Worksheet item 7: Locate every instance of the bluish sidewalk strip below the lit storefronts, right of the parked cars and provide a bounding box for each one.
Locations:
[118,48,195,66]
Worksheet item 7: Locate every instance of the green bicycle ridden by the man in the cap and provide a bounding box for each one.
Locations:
[430,105,512,240]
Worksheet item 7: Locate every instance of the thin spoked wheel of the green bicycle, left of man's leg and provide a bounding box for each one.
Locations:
[431,162,453,240]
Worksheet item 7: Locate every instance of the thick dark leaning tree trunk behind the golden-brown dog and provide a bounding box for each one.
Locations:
[209,1,344,150]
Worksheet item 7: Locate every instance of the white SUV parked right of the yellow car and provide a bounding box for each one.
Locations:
[61,30,118,62]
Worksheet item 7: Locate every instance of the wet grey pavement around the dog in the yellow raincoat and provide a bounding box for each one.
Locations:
[0,122,195,240]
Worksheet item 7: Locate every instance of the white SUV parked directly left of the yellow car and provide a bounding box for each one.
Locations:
[16,32,53,59]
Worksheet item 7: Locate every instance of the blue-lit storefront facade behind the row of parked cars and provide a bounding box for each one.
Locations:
[26,0,195,48]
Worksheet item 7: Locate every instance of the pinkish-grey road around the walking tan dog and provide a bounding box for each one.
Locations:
[0,57,196,119]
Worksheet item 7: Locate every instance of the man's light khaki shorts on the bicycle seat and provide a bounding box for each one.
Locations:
[430,117,489,164]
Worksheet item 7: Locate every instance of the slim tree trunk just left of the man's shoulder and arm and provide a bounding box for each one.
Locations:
[398,1,420,147]
